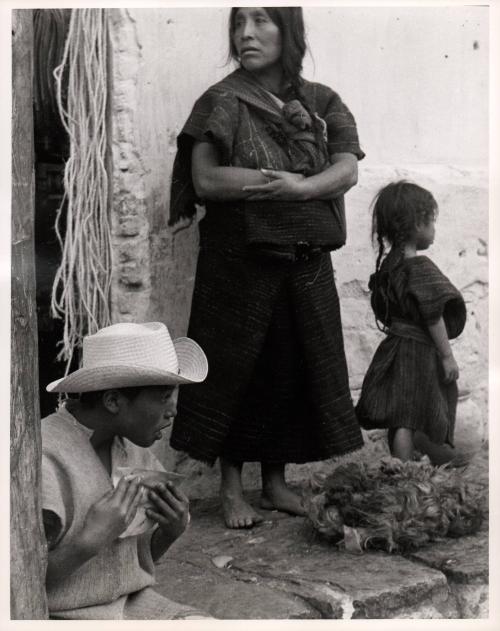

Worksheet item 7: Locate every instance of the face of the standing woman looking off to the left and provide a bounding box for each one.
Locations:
[233,7,281,73]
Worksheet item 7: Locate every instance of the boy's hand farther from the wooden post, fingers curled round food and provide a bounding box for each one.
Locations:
[146,482,190,545]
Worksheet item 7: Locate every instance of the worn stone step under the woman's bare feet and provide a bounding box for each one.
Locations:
[156,495,488,620]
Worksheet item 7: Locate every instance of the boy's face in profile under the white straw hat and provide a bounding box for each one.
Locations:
[120,386,178,447]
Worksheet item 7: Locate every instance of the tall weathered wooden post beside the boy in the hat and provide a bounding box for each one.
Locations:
[10,9,48,620]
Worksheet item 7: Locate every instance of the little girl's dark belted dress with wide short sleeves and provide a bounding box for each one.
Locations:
[356,254,466,445]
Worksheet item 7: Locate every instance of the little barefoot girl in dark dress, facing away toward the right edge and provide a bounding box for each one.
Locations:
[356,181,466,460]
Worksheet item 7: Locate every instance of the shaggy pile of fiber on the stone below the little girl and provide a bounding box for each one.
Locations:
[308,458,482,553]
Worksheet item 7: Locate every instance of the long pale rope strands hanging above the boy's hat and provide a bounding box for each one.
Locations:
[51,9,112,373]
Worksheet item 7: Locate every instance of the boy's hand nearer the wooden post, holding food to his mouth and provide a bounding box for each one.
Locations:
[82,478,144,551]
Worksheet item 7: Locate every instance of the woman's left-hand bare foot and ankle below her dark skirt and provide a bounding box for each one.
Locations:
[220,458,264,528]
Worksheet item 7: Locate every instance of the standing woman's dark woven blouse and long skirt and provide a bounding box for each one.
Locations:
[170,70,364,464]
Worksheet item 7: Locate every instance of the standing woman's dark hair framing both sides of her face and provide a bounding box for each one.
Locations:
[229,7,307,87]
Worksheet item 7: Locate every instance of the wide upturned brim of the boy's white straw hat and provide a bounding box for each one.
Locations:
[46,337,208,393]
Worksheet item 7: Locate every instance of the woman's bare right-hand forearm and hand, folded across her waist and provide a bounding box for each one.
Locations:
[244,153,358,201]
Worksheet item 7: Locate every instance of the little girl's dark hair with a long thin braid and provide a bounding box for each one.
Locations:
[372,180,438,331]
